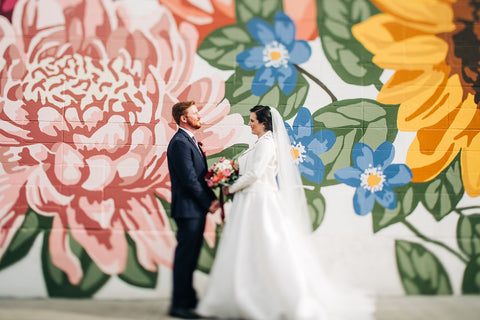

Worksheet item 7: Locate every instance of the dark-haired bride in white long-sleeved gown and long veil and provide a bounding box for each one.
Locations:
[197,106,374,320]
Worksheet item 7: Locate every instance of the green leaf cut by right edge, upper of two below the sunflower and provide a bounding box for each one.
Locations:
[457,214,480,256]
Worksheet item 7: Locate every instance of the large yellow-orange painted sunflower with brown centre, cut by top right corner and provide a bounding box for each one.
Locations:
[352,0,480,197]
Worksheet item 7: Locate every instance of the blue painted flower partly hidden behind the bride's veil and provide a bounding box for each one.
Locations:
[285,108,337,183]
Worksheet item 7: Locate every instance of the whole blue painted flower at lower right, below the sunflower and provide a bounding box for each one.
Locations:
[335,141,412,216]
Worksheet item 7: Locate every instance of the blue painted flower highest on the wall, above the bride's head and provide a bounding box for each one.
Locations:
[237,11,311,96]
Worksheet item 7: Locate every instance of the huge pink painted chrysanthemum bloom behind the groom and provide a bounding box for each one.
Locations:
[0,0,243,284]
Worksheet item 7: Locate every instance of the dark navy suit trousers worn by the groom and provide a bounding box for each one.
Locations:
[172,216,206,308]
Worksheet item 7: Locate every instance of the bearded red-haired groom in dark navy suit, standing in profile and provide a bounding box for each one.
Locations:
[167,101,219,319]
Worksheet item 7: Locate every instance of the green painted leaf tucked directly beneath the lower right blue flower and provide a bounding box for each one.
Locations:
[372,184,419,233]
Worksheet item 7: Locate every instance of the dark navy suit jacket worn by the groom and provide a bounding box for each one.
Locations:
[167,129,215,218]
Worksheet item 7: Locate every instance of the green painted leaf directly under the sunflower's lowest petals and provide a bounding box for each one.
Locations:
[415,155,464,221]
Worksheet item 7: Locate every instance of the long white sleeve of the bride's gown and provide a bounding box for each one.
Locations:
[228,139,275,193]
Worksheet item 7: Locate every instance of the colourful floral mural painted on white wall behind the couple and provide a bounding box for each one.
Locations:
[0,0,480,297]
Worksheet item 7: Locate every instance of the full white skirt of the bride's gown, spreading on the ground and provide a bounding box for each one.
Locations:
[197,189,373,320]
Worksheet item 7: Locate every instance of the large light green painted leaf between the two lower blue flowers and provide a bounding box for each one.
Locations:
[312,99,398,186]
